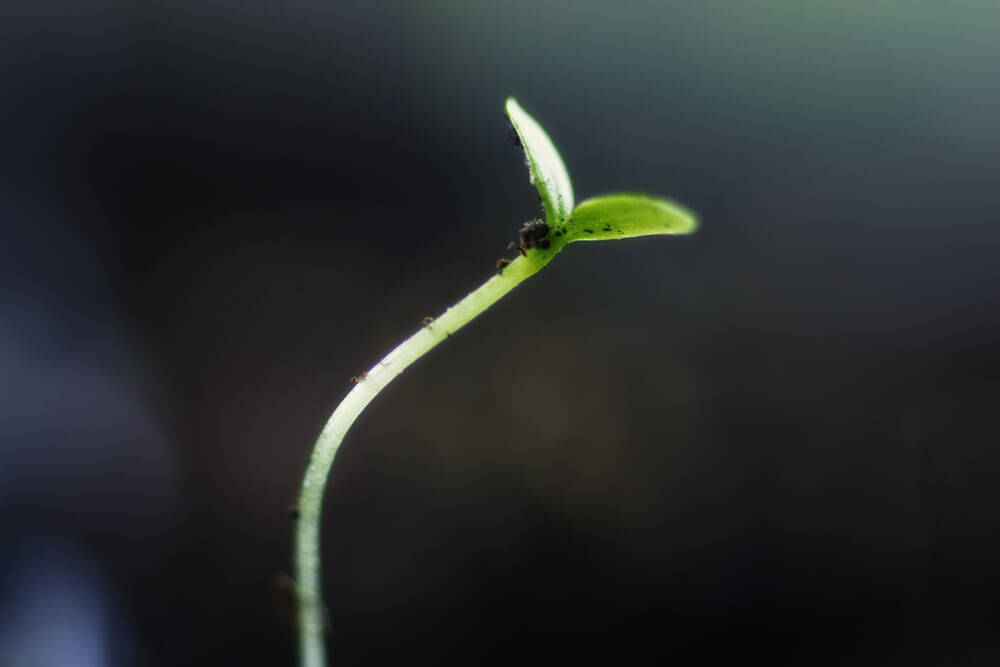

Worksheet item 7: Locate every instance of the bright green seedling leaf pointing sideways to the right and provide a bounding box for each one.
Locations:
[556,193,698,243]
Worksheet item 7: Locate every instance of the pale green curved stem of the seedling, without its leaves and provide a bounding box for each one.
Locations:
[295,243,562,667]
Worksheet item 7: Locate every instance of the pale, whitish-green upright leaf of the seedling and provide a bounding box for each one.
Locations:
[507,97,573,225]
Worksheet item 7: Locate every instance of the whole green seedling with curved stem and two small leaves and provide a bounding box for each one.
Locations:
[294,98,698,667]
